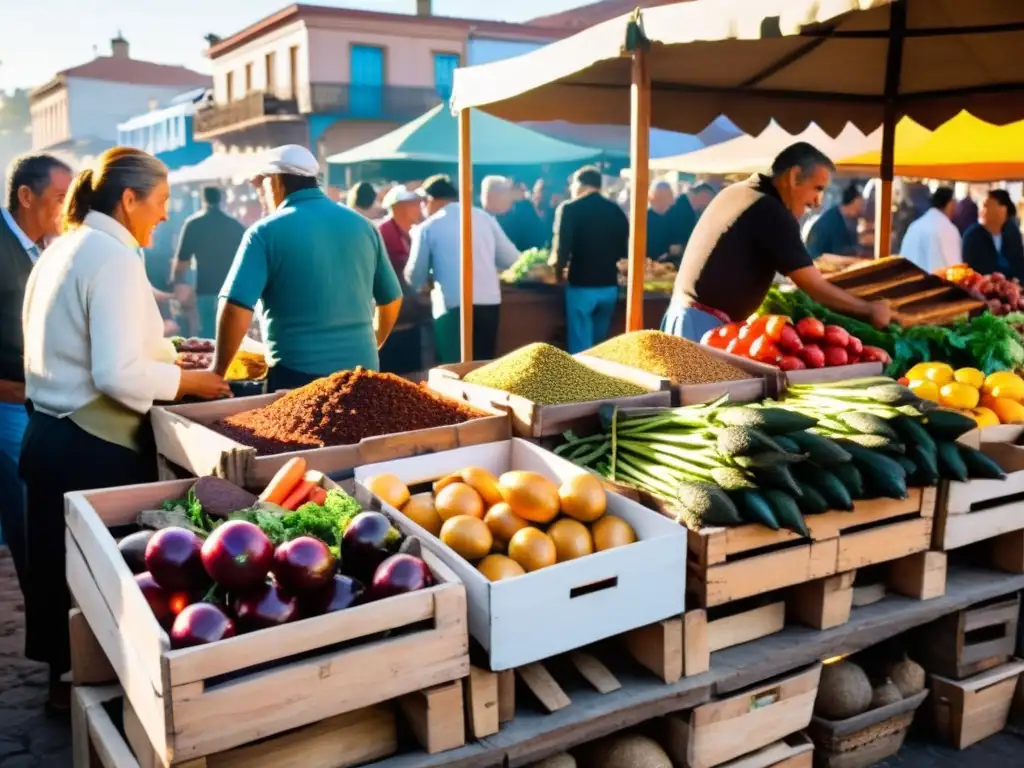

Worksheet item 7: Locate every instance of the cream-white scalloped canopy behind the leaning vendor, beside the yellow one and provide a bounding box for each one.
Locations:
[650,121,882,176]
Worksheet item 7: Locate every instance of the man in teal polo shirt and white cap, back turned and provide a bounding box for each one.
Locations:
[214,144,401,391]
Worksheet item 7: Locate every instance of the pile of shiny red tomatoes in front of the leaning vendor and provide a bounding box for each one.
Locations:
[700,314,891,371]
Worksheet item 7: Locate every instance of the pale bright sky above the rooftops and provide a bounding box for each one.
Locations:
[0,0,588,91]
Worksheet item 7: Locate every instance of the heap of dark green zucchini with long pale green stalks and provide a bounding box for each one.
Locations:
[555,377,1005,536]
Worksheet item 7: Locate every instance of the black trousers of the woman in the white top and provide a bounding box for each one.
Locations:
[20,412,157,676]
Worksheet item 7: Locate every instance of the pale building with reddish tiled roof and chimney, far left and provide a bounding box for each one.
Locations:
[29,35,211,163]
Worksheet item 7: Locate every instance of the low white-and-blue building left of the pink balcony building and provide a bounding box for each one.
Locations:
[118,88,213,171]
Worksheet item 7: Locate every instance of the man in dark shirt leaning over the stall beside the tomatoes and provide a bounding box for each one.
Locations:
[662,141,893,341]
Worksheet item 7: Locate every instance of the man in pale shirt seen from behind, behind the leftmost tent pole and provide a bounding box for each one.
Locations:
[406,175,519,364]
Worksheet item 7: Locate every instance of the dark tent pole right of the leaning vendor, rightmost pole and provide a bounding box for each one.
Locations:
[874,0,906,259]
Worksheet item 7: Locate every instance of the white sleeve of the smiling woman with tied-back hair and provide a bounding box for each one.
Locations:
[87,259,181,414]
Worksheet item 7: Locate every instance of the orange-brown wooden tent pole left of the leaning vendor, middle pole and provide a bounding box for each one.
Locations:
[626,45,650,331]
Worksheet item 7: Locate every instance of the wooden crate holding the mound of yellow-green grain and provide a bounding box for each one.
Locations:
[428,359,672,438]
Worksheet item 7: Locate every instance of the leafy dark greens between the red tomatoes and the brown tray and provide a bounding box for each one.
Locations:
[759,286,1024,376]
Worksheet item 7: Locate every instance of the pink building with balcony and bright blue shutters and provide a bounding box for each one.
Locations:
[196,0,563,158]
